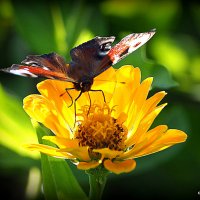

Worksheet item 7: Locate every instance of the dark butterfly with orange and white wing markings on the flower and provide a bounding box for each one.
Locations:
[1,29,156,108]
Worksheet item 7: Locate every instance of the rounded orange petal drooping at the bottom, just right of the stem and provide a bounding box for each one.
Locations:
[103,160,136,174]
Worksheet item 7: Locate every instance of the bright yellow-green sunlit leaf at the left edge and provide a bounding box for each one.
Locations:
[0,86,39,158]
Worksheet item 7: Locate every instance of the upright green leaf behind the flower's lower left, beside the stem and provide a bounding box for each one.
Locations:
[34,122,87,200]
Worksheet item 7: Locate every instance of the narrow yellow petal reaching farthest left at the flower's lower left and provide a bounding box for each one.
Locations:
[24,144,75,159]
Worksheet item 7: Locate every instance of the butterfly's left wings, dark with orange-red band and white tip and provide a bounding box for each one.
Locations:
[1,53,73,82]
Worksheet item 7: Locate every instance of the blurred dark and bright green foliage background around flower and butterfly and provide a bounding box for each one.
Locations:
[0,0,200,200]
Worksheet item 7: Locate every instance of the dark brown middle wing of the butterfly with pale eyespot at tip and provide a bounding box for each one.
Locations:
[67,36,115,82]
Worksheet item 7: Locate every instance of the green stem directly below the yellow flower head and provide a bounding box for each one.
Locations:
[87,168,108,200]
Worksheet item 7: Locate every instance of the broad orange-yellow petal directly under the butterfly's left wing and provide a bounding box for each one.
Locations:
[37,80,90,129]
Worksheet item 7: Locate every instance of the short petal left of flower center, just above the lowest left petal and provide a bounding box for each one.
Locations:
[42,136,79,148]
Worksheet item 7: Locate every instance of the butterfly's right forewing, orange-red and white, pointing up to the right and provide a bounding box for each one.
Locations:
[94,29,155,76]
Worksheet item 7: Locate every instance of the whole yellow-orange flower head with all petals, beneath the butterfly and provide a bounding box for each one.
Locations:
[24,66,187,174]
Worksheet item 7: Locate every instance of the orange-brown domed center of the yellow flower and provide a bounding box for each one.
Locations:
[74,104,128,155]
